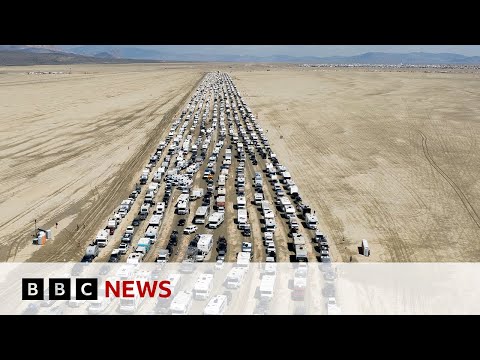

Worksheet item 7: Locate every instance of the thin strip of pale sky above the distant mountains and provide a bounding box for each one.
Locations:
[59,45,480,57]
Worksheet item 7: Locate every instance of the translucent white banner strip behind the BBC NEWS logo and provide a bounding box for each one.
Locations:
[0,263,480,315]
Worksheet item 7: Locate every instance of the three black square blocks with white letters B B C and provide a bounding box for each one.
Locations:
[22,278,98,300]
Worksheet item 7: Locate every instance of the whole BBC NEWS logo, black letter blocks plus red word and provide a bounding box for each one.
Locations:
[22,278,172,300]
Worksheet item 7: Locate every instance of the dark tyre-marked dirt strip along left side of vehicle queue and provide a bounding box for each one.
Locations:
[23,74,203,262]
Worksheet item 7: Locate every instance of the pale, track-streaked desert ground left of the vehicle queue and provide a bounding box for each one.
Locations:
[0,64,204,261]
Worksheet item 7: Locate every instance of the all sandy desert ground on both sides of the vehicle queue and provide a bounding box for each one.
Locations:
[0,64,480,262]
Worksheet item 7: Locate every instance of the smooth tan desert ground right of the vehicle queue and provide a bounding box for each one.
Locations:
[230,67,480,262]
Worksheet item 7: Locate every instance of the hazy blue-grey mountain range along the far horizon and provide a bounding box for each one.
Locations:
[0,45,480,65]
